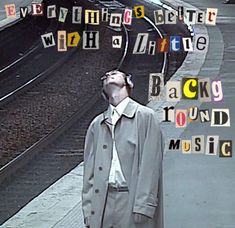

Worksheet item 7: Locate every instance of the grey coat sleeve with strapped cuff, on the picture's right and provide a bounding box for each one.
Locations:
[133,112,164,218]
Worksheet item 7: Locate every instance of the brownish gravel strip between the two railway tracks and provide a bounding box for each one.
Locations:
[0,23,122,167]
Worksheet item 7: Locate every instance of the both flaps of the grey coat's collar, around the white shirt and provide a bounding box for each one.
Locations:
[101,98,138,124]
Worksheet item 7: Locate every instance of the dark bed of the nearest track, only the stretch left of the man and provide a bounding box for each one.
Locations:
[0,98,106,224]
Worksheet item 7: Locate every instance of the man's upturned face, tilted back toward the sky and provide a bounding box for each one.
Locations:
[101,70,126,88]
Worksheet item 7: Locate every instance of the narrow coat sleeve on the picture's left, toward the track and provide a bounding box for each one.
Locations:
[82,120,95,225]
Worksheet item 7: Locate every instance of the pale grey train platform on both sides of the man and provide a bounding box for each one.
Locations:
[0,0,235,228]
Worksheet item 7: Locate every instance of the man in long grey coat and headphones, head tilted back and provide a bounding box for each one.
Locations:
[82,70,164,228]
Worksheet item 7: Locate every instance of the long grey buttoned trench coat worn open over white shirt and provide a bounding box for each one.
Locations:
[82,100,164,228]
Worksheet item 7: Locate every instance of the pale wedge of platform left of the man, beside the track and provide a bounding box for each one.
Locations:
[0,164,85,228]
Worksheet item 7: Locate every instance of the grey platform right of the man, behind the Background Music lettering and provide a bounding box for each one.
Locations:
[151,0,235,228]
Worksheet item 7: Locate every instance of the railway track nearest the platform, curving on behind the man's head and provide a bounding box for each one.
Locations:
[0,0,187,224]
